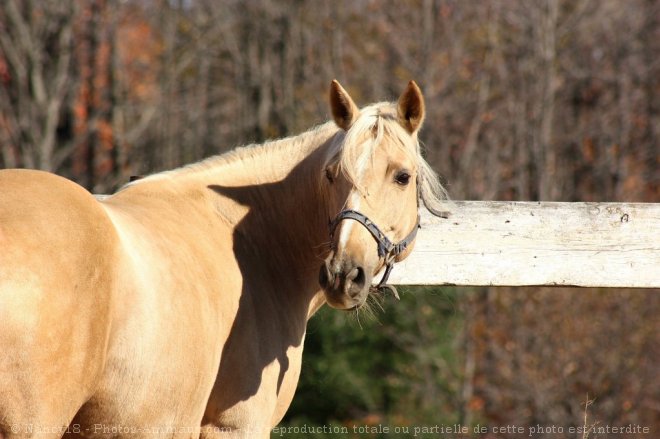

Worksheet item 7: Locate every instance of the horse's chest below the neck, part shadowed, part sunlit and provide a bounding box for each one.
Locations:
[205,295,304,428]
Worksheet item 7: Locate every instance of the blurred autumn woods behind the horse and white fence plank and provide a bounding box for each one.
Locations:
[0,0,660,438]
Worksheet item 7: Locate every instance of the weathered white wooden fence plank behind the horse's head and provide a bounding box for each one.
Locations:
[390,201,660,288]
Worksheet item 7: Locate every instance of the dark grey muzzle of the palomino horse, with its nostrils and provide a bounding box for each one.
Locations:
[319,255,372,309]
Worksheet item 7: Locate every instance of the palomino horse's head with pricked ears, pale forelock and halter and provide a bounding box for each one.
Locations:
[319,81,444,309]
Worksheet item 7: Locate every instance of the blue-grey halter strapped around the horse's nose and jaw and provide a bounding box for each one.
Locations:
[330,209,420,299]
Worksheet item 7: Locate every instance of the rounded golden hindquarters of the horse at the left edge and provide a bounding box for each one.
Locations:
[0,170,117,436]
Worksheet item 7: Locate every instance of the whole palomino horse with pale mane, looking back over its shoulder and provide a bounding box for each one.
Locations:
[0,81,443,438]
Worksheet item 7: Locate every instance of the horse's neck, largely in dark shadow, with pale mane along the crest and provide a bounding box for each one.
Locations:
[124,127,336,315]
